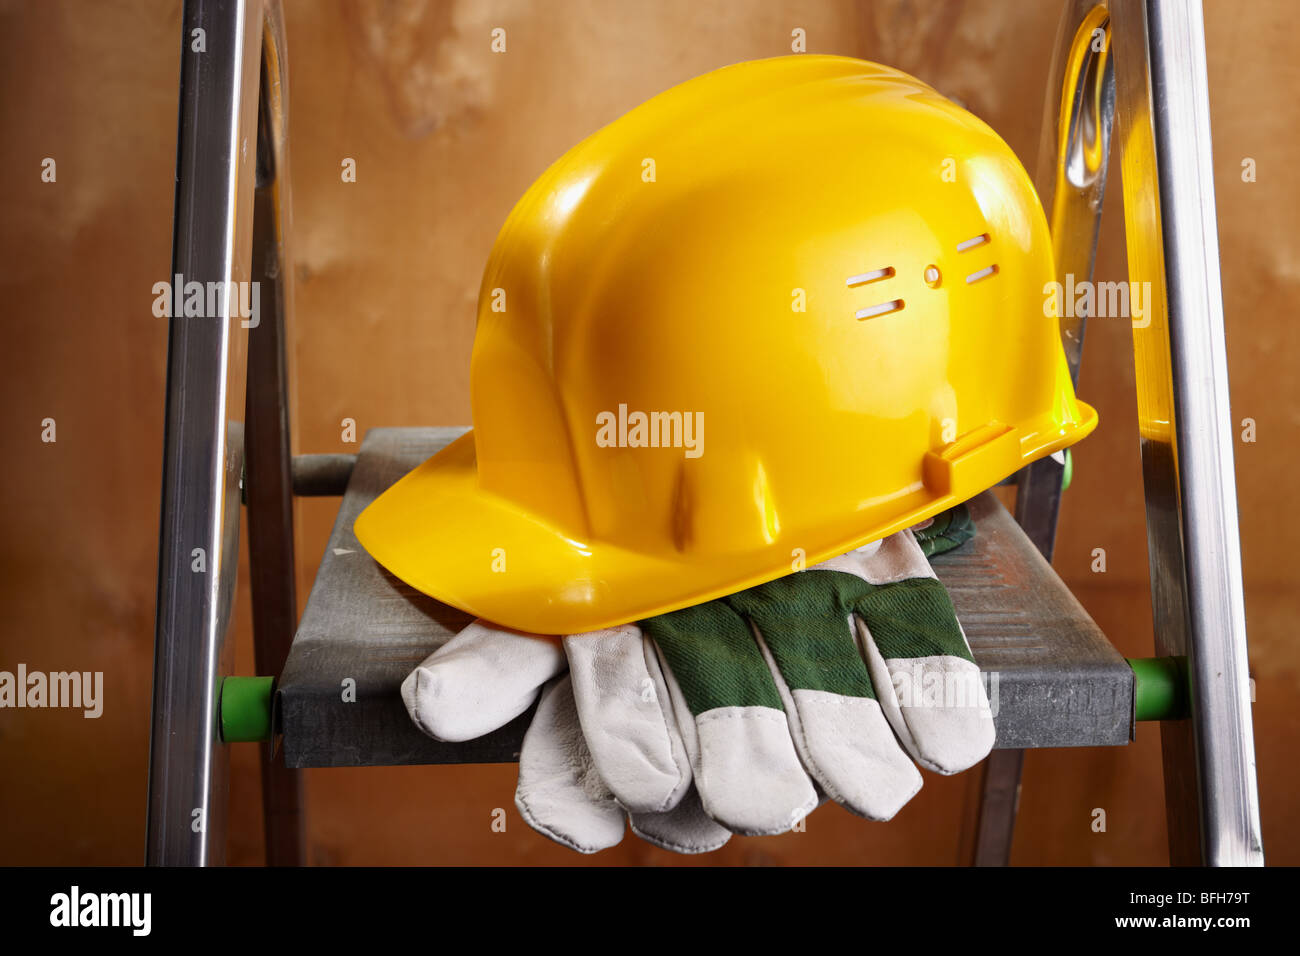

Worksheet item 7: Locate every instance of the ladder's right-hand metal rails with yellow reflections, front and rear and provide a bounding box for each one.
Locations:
[975,0,1264,866]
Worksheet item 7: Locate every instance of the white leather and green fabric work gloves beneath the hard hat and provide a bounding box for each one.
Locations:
[402,509,993,853]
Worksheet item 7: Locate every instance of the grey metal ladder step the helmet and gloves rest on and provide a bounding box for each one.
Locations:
[276,428,1134,767]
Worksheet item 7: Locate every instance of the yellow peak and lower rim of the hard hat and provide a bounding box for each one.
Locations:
[354,402,1097,635]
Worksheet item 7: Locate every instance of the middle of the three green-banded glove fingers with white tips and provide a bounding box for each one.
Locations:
[728,570,922,819]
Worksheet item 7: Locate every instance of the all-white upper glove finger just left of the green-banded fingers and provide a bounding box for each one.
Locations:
[564,624,692,813]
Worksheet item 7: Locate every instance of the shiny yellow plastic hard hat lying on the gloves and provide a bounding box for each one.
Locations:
[355,56,1097,633]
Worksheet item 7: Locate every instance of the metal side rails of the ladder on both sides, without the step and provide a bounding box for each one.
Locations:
[147,0,1262,865]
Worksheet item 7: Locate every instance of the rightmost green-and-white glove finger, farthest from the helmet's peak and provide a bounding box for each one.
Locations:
[855,532,995,774]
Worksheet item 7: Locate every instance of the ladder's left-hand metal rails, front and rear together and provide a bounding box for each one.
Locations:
[146,0,302,866]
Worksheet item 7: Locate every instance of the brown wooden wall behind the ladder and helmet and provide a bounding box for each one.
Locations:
[0,0,1300,864]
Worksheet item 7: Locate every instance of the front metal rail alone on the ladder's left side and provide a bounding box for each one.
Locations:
[146,0,287,865]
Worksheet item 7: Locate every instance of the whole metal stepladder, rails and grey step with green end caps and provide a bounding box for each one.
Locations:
[147,0,1262,865]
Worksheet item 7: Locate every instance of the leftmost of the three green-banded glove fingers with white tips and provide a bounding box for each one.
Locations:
[641,601,816,835]
